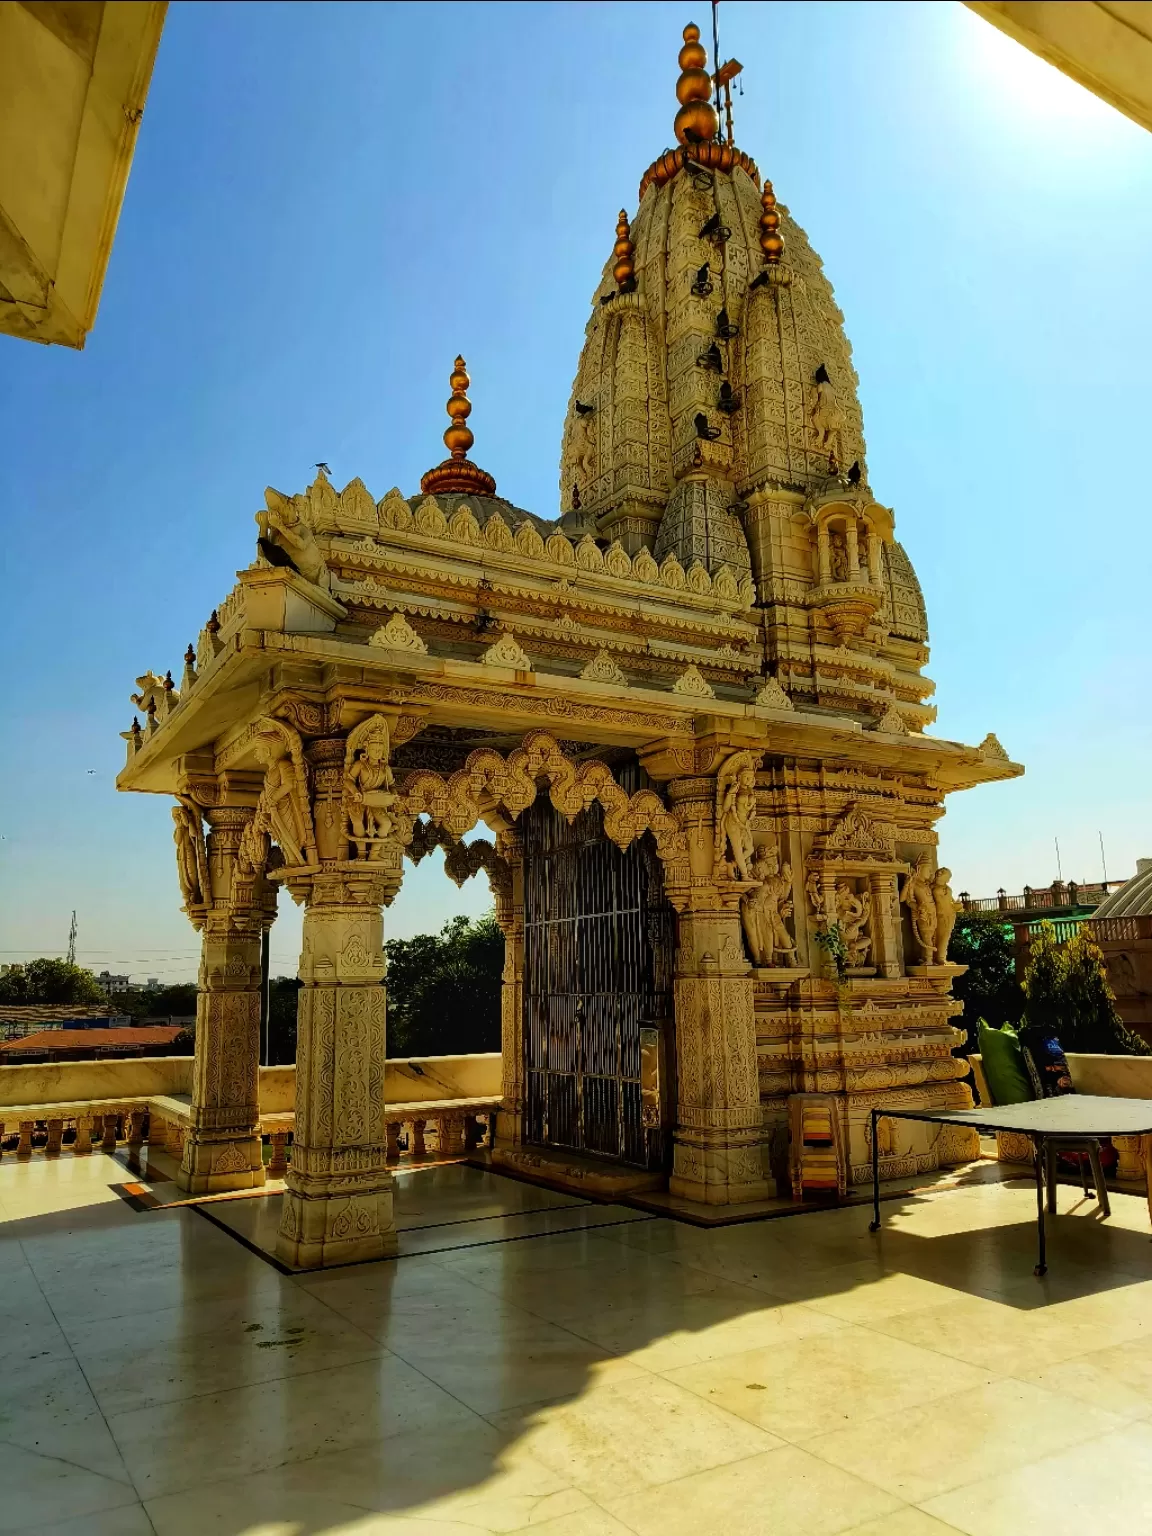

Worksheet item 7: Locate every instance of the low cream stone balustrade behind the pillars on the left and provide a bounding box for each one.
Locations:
[0,1052,501,1178]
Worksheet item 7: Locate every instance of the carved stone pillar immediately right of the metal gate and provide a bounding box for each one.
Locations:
[668,777,768,1206]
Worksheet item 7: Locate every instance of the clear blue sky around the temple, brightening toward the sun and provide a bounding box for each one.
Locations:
[0,0,1152,980]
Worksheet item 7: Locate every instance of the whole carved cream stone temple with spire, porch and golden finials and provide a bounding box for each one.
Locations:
[118,26,1023,1267]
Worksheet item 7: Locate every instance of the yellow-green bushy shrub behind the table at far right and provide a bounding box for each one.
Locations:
[1025,923,1150,1055]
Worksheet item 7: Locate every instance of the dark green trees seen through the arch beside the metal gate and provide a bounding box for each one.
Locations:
[384,914,504,1057]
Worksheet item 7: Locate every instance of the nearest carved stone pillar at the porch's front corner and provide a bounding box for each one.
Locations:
[276,841,401,1269]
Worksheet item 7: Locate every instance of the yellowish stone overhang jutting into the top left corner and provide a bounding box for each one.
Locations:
[0,0,167,347]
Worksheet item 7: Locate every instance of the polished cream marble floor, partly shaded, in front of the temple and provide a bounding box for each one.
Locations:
[0,1155,1152,1536]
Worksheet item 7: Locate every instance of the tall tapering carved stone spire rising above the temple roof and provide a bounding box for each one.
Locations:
[561,32,866,568]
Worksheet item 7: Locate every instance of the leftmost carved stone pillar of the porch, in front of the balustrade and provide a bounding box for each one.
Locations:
[177,806,275,1195]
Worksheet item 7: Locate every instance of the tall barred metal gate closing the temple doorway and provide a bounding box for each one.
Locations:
[521,770,673,1167]
